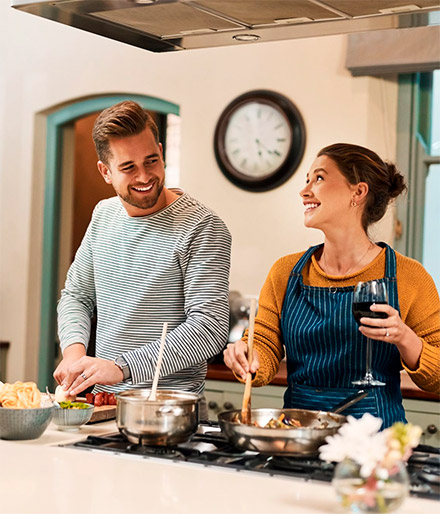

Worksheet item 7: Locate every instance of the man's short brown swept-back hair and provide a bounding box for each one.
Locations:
[92,100,159,165]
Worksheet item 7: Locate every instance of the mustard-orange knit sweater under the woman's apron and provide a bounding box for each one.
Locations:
[243,249,440,392]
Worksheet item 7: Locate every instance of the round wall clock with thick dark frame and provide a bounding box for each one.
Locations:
[214,90,306,191]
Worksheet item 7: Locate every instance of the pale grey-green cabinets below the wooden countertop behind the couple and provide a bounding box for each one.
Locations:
[205,380,440,447]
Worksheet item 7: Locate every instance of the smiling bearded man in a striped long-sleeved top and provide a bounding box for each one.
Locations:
[54,101,231,396]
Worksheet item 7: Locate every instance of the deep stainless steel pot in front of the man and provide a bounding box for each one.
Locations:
[116,389,202,446]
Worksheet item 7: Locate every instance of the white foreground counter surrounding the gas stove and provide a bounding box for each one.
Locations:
[0,422,439,514]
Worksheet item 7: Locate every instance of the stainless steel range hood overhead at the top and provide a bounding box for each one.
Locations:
[12,0,440,52]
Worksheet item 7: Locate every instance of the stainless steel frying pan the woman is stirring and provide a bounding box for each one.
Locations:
[218,390,368,456]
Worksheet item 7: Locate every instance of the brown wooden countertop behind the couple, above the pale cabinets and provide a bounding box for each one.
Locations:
[206,361,440,402]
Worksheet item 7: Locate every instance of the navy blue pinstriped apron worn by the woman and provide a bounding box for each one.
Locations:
[281,243,406,428]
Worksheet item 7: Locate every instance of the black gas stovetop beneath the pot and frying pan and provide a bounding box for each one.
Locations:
[65,422,440,500]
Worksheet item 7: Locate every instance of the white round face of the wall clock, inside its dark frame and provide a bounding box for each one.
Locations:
[225,102,292,178]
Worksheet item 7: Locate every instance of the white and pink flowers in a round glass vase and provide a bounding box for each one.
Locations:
[319,414,422,512]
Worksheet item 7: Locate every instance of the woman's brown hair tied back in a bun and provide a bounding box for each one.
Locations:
[318,143,407,232]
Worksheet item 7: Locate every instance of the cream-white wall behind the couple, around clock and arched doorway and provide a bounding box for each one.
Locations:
[0,1,397,380]
